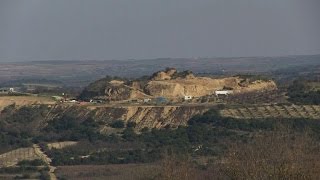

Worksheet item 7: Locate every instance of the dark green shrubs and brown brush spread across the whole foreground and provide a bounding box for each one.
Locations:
[0,102,320,179]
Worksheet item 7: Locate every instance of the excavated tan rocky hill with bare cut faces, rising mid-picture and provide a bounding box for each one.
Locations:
[80,68,277,100]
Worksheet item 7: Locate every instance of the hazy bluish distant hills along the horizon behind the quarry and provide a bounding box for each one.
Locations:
[0,55,320,87]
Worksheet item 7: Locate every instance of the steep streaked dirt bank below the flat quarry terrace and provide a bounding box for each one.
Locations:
[44,106,208,129]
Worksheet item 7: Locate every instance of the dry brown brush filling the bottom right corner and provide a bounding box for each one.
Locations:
[221,132,320,179]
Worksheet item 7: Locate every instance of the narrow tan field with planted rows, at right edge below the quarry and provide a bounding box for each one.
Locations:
[221,105,320,119]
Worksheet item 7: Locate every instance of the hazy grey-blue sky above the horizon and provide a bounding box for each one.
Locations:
[0,0,320,61]
